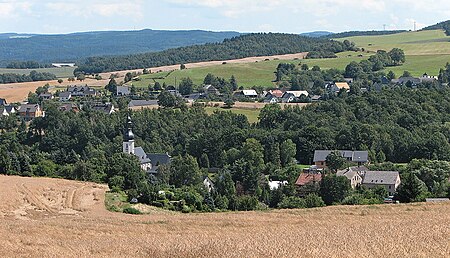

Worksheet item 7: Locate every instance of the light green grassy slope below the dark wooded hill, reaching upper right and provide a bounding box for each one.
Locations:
[134,30,450,88]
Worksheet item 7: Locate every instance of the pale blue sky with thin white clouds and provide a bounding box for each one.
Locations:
[0,0,450,34]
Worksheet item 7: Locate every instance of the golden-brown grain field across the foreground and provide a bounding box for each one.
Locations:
[0,176,450,257]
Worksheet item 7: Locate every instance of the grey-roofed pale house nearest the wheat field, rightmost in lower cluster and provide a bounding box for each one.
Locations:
[362,171,400,195]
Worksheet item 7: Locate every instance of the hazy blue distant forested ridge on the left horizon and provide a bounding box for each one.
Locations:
[0,29,241,66]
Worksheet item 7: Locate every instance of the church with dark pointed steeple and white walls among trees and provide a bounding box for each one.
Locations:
[122,116,171,174]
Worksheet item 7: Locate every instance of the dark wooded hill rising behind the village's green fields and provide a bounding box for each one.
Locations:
[75,33,356,74]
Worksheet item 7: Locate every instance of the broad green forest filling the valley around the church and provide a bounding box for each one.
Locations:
[0,87,450,212]
